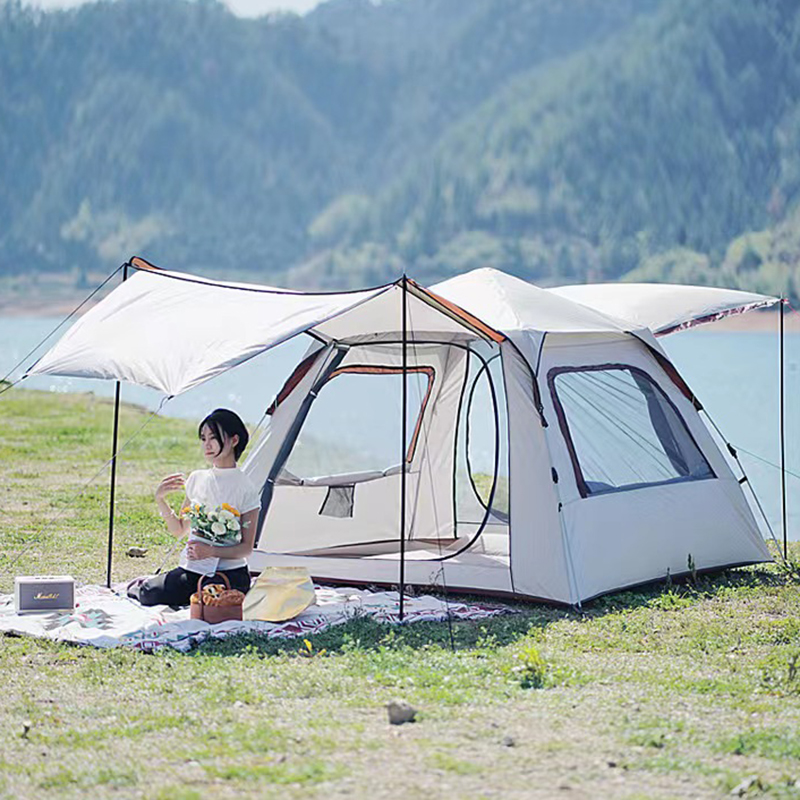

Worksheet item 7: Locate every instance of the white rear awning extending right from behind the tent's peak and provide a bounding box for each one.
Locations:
[550,283,780,336]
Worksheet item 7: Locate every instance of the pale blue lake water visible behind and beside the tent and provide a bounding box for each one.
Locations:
[0,317,800,540]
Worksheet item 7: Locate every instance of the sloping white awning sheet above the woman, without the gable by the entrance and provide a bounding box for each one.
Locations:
[28,259,391,395]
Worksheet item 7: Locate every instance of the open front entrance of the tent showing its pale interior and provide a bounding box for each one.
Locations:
[250,340,508,560]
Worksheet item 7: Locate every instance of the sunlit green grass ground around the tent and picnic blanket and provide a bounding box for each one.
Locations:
[0,390,800,800]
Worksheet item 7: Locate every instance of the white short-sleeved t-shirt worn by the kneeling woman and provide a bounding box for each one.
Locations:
[179,467,261,575]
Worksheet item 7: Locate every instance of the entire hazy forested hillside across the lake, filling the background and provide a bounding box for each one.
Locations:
[0,0,800,293]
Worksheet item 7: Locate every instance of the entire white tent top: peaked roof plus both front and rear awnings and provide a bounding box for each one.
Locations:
[28,258,778,396]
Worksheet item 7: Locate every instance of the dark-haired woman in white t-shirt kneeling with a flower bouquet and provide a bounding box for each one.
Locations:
[128,408,261,606]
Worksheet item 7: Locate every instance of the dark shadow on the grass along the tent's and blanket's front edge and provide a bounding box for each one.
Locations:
[191,565,798,657]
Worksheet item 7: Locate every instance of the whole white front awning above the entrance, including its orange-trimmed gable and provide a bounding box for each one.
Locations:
[27,258,503,396]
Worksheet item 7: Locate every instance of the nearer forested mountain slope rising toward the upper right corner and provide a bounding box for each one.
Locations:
[297,0,800,293]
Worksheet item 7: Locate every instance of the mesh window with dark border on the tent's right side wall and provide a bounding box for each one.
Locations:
[548,365,714,497]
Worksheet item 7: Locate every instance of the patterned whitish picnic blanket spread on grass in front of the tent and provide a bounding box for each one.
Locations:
[0,584,511,652]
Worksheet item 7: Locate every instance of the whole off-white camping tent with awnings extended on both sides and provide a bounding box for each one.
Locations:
[29,259,778,604]
